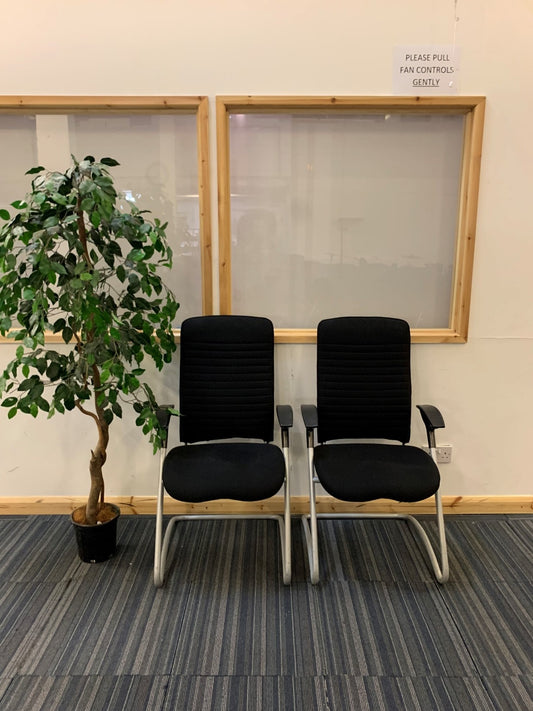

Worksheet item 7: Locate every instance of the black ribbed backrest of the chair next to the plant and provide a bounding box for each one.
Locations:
[179,316,274,442]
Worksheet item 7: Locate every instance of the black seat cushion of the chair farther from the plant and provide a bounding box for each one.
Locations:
[314,443,440,501]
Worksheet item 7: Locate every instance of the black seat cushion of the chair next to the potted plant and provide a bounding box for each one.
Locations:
[163,442,285,503]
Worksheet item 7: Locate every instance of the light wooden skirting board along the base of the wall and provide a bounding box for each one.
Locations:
[0,496,533,516]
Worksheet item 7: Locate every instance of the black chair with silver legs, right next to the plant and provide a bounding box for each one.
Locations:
[154,316,292,587]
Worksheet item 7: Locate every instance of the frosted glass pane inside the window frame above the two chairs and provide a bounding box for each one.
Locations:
[229,113,465,328]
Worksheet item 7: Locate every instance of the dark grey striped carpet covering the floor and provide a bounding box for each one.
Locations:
[0,516,533,711]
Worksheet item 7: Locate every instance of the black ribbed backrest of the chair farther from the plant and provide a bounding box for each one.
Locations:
[317,316,411,443]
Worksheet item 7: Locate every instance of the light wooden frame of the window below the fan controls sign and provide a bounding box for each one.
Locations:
[216,96,485,343]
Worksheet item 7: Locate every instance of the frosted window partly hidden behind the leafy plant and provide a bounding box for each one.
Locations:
[0,97,212,327]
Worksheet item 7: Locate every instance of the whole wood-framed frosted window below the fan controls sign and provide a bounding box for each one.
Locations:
[216,96,485,343]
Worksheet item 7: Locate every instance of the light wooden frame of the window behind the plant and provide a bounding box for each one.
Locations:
[0,96,213,343]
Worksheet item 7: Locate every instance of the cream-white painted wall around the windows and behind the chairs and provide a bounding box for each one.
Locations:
[0,0,533,496]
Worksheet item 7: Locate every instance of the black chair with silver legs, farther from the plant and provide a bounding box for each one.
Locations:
[302,317,449,583]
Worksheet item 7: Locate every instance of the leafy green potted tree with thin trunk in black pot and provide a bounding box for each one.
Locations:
[0,156,179,561]
